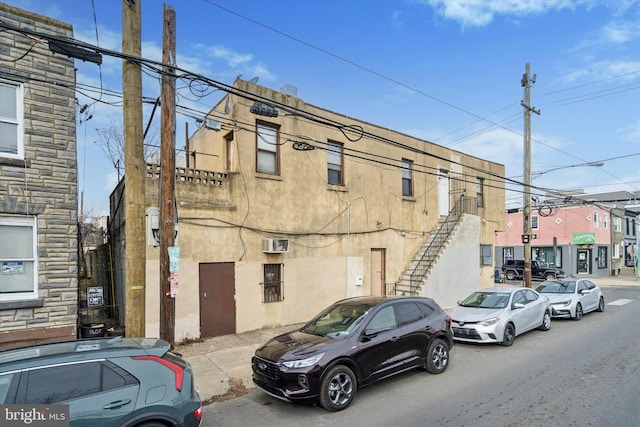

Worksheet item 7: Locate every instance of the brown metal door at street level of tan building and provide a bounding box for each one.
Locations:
[199,262,236,338]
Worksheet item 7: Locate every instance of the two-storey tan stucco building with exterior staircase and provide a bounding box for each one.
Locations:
[112,79,504,341]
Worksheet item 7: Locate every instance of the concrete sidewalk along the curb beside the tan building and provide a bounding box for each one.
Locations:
[175,276,640,404]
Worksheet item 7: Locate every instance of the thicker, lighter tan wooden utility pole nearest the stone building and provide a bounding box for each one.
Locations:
[122,0,146,337]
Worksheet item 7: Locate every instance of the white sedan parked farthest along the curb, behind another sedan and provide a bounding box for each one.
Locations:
[536,279,604,320]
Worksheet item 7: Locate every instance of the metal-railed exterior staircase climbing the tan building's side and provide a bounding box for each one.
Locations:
[387,195,477,295]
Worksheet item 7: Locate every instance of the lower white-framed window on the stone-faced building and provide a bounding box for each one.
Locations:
[0,216,38,301]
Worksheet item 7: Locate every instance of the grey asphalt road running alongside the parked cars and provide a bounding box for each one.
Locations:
[202,287,640,427]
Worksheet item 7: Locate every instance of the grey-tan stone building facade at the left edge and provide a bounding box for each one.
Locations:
[0,3,78,348]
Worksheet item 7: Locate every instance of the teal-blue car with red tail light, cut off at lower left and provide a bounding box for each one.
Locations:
[0,337,202,427]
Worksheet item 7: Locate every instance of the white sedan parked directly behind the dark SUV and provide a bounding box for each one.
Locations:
[451,287,551,346]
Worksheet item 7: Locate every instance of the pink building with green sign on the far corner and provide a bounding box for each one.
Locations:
[495,205,614,276]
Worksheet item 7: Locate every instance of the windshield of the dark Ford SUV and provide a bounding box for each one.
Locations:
[300,303,371,338]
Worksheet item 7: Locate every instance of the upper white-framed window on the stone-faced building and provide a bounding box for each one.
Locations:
[0,81,24,159]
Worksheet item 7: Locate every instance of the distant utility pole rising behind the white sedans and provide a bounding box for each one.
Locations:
[520,63,540,288]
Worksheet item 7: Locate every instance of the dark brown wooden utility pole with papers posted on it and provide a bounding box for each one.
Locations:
[159,4,178,347]
